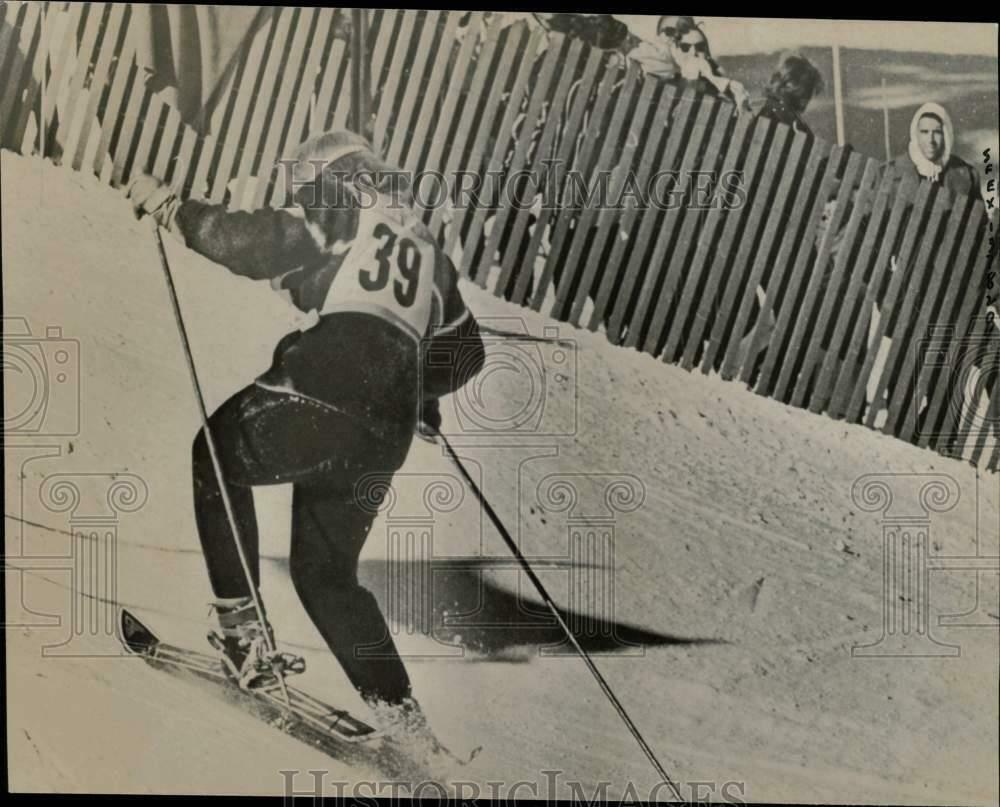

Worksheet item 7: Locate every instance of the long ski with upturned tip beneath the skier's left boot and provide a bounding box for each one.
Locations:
[120,608,380,758]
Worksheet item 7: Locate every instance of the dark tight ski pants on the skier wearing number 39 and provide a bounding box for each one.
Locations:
[193,384,412,703]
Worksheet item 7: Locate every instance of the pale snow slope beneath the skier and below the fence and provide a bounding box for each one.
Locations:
[0,152,1000,804]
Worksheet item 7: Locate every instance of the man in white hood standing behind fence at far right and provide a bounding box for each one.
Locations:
[889,103,979,196]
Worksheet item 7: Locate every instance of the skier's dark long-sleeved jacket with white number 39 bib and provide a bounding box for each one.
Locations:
[173,196,484,434]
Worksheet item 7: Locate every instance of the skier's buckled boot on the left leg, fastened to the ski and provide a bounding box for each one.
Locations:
[208,597,306,690]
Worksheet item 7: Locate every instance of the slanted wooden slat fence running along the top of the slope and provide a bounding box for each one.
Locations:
[0,2,1000,470]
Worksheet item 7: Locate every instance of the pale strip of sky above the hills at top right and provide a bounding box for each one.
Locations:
[615,14,998,58]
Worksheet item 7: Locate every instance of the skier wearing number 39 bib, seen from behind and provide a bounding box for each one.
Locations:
[128,131,484,744]
